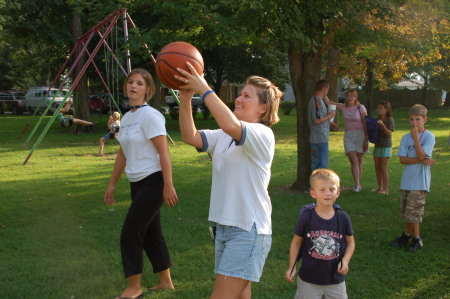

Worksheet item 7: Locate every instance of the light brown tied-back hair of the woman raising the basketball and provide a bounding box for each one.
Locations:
[246,76,283,127]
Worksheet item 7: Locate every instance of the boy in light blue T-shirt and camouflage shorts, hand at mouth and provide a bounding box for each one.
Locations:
[390,104,435,252]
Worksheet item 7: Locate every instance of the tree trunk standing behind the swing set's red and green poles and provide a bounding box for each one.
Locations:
[71,12,90,132]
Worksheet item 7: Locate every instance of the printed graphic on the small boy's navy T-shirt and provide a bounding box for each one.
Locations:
[306,230,342,260]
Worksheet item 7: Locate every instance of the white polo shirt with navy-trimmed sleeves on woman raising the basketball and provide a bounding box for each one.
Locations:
[199,122,275,234]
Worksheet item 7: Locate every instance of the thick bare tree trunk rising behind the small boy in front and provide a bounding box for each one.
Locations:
[288,43,322,191]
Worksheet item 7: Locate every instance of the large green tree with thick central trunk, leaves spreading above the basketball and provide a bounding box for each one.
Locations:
[127,0,404,190]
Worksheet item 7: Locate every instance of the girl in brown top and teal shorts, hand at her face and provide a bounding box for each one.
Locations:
[373,101,394,195]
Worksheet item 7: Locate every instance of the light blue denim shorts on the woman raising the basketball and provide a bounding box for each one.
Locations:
[214,224,272,282]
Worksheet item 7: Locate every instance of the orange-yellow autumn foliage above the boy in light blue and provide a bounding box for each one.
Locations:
[340,0,450,106]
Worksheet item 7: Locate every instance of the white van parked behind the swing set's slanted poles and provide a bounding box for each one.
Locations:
[25,86,69,113]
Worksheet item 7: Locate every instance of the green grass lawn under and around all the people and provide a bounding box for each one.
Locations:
[0,109,450,299]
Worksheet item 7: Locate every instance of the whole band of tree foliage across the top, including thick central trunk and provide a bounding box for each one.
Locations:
[0,0,450,190]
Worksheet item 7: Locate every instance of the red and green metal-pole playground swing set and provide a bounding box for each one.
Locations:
[22,8,179,165]
